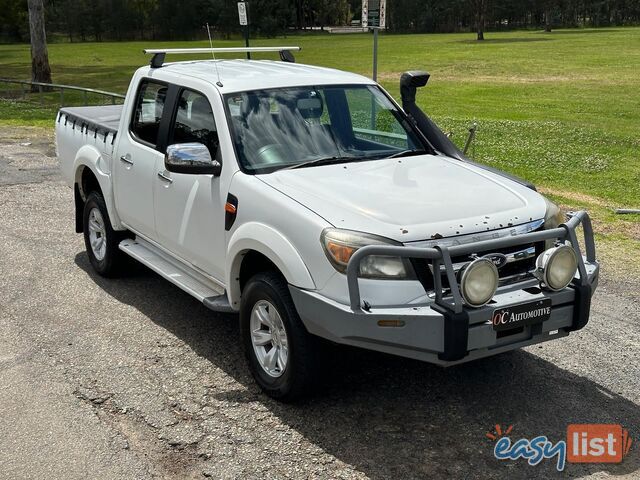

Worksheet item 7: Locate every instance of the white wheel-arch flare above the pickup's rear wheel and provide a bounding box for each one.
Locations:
[73,145,125,230]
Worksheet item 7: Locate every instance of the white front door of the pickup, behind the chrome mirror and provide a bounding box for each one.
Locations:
[154,89,226,281]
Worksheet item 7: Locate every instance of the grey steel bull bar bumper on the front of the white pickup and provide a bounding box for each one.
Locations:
[290,212,599,365]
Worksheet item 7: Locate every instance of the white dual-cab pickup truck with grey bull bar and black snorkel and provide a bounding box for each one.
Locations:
[56,47,599,400]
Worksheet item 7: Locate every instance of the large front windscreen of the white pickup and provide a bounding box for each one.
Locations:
[225,85,429,173]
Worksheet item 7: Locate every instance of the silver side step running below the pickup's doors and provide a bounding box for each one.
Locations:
[118,238,233,312]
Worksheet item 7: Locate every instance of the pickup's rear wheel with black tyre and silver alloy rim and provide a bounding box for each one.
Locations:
[82,192,126,277]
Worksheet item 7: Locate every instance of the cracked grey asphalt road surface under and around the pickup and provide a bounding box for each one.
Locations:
[0,128,640,479]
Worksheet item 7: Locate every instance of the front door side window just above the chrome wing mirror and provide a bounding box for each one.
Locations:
[169,90,218,158]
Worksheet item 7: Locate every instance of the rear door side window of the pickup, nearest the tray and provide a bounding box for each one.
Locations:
[131,80,167,146]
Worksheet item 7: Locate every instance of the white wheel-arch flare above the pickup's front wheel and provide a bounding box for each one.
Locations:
[225,222,316,308]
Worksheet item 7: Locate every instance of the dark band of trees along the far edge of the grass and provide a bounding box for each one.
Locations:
[8,0,640,42]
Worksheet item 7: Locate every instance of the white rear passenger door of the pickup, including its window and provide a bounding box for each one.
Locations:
[113,79,169,240]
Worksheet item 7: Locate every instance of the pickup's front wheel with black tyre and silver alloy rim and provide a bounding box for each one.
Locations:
[240,272,319,402]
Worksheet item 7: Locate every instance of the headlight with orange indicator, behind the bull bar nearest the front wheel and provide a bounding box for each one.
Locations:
[320,228,415,280]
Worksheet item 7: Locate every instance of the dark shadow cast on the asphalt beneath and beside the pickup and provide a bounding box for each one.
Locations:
[75,253,640,479]
